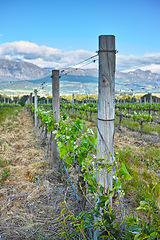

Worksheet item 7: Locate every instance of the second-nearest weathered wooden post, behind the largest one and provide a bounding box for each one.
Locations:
[52,70,60,170]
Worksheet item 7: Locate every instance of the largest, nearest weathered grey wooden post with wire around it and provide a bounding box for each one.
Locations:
[94,35,116,240]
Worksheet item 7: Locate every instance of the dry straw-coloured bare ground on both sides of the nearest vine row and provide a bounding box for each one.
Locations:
[0,109,160,240]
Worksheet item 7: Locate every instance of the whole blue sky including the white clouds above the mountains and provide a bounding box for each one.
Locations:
[0,0,160,73]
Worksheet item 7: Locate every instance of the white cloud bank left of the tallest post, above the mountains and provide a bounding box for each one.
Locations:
[0,41,94,68]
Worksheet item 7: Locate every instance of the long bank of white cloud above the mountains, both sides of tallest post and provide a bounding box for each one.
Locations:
[0,41,160,73]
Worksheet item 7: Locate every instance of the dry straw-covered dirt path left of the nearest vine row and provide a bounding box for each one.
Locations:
[0,109,77,240]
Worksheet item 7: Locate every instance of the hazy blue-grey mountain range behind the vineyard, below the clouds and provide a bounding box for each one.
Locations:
[0,59,160,95]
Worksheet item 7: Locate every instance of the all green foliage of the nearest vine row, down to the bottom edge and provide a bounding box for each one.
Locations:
[37,100,159,240]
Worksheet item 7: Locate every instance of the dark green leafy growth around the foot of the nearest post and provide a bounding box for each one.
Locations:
[59,158,160,240]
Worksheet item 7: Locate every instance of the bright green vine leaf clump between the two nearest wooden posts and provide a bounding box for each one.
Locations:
[54,114,96,166]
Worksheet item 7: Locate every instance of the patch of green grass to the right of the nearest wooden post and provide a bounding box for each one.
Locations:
[116,145,160,205]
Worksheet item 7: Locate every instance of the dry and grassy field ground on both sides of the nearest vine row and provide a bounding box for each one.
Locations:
[0,108,160,239]
